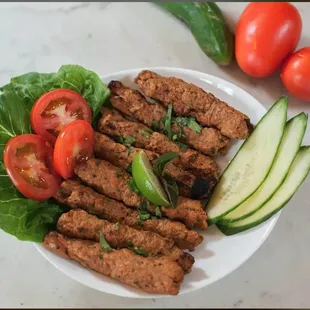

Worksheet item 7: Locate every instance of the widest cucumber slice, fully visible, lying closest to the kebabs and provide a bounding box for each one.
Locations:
[206,97,288,223]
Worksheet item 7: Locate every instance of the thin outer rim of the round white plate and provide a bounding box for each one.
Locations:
[33,66,282,299]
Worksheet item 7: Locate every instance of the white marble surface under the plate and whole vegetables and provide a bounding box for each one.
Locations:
[0,3,310,308]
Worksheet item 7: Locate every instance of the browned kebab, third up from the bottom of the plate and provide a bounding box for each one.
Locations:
[55,180,203,250]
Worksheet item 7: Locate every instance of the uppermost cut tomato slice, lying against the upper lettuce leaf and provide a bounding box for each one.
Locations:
[31,89,92,144]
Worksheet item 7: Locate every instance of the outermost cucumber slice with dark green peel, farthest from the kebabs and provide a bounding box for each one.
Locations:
[218,146,310,235]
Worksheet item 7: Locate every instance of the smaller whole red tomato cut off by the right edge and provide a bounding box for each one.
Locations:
[281,47,310,101]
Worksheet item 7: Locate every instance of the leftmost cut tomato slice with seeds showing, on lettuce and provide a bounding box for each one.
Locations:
[4,134,61,200]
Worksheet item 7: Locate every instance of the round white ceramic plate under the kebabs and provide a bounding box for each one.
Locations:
[35,68,279,298]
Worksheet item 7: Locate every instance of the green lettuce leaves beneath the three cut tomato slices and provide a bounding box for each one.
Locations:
[0,65,109,242]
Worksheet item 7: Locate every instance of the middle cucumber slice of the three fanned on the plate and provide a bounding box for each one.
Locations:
[219,113,308,224]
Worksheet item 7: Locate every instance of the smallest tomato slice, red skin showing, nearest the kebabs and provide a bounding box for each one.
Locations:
[54,120,95,179]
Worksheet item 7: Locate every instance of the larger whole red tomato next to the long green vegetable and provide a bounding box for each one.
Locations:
[236,2,302,77]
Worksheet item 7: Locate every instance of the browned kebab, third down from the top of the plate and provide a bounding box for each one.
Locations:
[97,108,218,182]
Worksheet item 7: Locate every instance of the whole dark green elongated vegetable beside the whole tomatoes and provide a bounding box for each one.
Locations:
[156,2,234,65]
